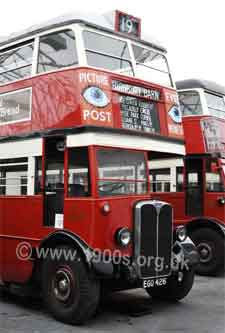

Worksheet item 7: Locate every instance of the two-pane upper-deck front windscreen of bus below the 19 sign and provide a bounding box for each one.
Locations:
[83,30,173,87]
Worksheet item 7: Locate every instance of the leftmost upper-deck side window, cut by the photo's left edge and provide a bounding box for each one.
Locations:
[0,42,33,84]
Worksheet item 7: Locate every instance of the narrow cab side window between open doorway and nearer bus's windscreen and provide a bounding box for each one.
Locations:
[68,147,91,197]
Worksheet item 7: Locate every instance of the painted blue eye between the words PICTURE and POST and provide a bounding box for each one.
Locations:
[83,87,109,108]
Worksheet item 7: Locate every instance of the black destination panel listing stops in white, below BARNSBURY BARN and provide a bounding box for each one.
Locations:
[120,95,160,133]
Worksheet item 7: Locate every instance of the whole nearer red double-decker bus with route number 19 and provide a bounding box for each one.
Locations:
[0,12,197,323]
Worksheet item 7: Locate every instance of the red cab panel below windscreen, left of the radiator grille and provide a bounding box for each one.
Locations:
[64,197,134,255]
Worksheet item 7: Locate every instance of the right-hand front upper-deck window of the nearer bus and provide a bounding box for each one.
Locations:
[132,45,173,86]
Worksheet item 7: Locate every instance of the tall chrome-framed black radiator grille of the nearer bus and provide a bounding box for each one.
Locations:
[135,201,173,278]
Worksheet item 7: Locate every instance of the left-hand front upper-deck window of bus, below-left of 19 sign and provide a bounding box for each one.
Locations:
[83,31,133,76]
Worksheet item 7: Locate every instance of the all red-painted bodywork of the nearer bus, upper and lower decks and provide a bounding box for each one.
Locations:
[0,68,183,282]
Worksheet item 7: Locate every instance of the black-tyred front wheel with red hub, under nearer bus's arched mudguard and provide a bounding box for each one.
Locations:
[42,246,100,324]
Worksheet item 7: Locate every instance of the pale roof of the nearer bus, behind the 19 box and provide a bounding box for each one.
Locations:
[0,12,166,52]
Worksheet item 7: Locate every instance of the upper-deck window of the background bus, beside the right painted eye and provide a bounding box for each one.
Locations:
[178,91,203,116]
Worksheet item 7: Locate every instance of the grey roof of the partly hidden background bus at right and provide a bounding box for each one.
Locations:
[176,79,225,95]
